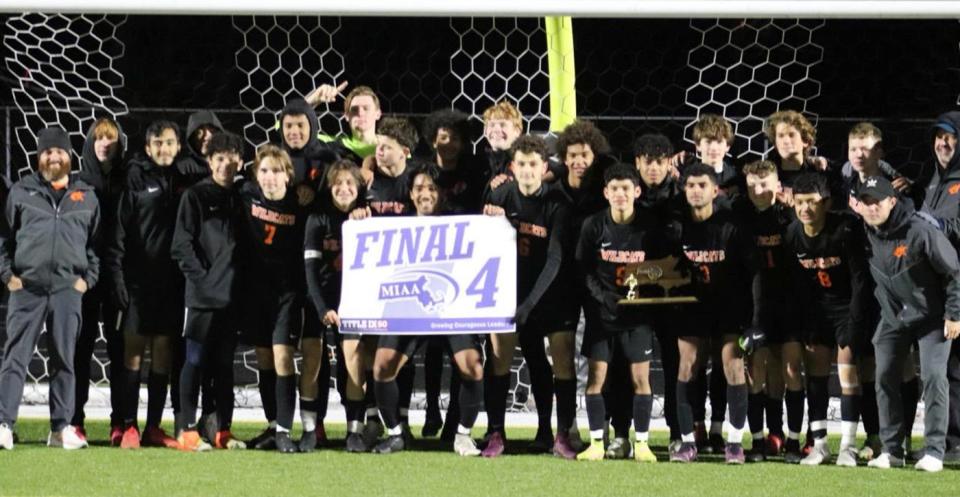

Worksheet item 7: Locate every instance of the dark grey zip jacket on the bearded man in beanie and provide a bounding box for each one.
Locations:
[0,173,100,293]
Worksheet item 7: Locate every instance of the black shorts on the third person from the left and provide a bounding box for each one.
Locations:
[122,287,183,336]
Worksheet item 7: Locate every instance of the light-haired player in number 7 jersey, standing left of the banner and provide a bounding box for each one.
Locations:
[240,145,325,453]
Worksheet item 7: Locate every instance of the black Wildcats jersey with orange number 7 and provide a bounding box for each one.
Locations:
[240,181,307,291]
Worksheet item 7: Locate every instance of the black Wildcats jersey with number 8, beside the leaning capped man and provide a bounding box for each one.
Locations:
[784,212,871,334]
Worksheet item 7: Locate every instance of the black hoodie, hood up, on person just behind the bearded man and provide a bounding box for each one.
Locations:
[78,121,127,258]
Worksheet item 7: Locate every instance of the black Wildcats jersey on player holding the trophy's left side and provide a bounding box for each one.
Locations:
[576,209,673,331]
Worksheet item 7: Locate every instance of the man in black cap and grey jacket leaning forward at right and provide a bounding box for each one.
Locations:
[859,176,960,472]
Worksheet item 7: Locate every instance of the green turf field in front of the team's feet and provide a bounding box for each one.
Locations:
[0,420,960,497]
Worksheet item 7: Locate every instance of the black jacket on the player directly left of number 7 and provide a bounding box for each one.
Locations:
[170,178,239,309]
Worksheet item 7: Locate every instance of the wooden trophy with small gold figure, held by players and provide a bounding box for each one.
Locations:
[618,256,697,305]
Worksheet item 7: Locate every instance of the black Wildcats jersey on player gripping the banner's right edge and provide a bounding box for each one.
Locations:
[489,181,568,314]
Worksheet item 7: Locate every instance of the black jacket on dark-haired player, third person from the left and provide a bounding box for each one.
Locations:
[104,157,198,291]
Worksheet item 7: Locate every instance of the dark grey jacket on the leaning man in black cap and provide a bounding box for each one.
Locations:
[867,198,960,332]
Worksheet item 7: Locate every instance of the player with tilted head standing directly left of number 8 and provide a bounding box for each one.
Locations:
[734,161,804,462]
